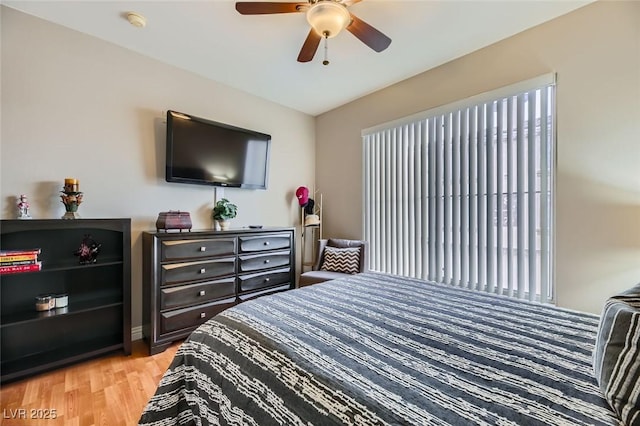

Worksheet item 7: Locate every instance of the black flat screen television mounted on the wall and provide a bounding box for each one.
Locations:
[166,110,271,189]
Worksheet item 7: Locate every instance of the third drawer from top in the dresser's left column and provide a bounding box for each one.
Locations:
[160,277,236,310]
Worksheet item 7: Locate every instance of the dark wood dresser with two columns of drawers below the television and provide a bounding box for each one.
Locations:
[142,228,295,355]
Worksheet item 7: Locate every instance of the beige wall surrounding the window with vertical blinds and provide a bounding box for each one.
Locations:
[316,1,640,313]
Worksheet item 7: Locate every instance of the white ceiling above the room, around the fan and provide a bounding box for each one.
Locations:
[2,0,593,116]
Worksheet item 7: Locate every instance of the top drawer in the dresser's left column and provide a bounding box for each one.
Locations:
[160,238,236,262]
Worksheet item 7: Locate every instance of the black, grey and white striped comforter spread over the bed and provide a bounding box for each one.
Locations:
[140,273,619,426]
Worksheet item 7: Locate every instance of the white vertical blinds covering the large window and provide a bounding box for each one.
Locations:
[362,75,555,302]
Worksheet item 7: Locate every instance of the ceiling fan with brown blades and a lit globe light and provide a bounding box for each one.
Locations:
[236,0,391,65]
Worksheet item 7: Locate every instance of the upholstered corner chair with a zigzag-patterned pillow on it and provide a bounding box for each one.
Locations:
[298,238,369,287]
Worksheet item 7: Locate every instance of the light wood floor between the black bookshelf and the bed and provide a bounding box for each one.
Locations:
[0,340,180,426]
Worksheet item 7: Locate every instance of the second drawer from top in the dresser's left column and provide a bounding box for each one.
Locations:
[160,257,236,285]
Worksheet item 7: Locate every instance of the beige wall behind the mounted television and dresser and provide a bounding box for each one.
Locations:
[0,7,315,326]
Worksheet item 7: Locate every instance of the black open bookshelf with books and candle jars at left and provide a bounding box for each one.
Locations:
[0,218,131,382]
